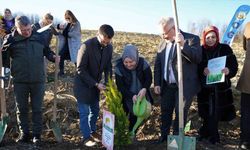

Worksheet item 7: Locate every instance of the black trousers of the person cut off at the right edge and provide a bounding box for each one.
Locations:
[240,93,250,143]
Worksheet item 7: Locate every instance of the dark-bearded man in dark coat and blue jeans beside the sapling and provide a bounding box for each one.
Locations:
[74,24,114,146]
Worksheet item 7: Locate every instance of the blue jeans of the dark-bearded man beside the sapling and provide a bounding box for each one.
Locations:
[78,101,100,139]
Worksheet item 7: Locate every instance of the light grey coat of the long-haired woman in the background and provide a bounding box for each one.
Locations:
[58,21,81,63]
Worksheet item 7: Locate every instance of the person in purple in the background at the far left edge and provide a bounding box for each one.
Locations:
[2,8,15,34]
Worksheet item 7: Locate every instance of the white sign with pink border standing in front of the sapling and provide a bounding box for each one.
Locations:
[102,110,115,150]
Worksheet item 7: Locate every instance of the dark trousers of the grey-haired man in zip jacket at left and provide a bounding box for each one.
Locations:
[14,83,45,135]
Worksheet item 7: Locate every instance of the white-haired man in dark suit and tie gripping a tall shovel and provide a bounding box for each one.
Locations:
[154,17,202,142]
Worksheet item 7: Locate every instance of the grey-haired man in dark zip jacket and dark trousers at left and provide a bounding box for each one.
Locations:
[2,16,59,143]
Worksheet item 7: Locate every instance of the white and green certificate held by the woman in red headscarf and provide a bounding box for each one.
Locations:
[206,56,226,84]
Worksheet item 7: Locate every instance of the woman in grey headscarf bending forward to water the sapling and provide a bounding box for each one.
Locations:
[115,44,153,131]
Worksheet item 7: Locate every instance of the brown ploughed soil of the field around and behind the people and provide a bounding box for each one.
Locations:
[0,31,244,150]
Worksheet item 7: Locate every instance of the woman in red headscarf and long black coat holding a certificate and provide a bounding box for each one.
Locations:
[197,26,238,144]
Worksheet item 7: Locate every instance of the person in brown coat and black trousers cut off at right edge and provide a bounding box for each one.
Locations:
[236,22,250,149]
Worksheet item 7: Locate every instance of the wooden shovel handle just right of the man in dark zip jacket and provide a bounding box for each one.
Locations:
[53,36,59,121]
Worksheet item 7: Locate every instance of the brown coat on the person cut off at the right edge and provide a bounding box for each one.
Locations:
[236,35,250,94]
